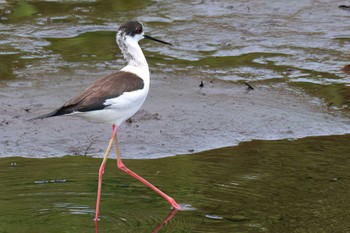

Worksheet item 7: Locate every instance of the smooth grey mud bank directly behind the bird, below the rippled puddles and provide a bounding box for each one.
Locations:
[0,70,350,158]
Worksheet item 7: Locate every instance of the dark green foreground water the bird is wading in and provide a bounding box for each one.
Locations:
[0,135,350,233]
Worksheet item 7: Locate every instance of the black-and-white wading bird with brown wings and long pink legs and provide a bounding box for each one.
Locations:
[33,21,180,221]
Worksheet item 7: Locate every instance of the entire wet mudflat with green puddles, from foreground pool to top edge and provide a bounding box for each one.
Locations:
[0,0,350,158]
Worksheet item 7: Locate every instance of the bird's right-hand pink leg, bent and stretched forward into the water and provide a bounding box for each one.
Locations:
[114,127,180,210]
